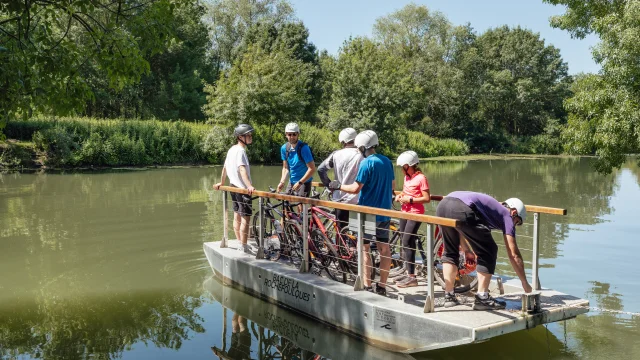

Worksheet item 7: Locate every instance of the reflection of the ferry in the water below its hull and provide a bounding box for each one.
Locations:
[204,277,409,360]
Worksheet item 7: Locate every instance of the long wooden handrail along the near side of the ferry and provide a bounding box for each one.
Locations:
[215,186,460,227]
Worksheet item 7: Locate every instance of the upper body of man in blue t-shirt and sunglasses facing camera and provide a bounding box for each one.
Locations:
[277,123,316,197]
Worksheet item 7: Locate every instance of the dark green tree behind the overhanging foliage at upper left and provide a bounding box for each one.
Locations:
[86,3,218,120]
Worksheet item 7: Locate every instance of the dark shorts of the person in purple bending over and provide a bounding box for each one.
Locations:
[436,197,498,274]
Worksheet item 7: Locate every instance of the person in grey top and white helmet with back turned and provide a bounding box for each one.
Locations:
[318,128,364,229]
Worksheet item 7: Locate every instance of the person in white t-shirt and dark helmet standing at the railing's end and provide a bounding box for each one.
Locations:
[213,124,255,253]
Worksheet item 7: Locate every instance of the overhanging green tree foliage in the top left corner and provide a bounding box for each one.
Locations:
[0,0,185,136]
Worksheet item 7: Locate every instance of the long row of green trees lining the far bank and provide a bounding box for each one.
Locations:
[0,0,573,160]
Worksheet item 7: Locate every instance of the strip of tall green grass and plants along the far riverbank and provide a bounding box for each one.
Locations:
[0,117,469,168]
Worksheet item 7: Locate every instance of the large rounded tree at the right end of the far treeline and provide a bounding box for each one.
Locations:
[475,26,572,135]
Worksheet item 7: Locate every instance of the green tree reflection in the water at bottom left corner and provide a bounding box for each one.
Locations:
[0,291,204,359]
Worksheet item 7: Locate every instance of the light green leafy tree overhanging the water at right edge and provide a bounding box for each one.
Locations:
[545,0,640,173]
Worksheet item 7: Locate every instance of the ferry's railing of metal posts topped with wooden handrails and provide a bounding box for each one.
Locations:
[219,183,567,313]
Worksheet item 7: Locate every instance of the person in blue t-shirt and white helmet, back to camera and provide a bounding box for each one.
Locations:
[329,130,396,296]
